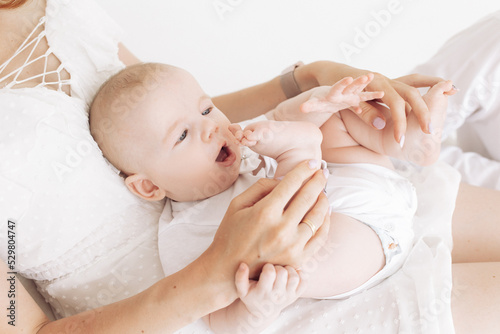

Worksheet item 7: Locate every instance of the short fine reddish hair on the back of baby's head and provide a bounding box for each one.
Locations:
[89,63,174,175]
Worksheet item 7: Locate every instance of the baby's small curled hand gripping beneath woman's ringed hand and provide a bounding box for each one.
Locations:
[235,263,305,318]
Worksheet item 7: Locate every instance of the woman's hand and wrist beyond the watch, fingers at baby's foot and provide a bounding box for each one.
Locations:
[295,61,443,142]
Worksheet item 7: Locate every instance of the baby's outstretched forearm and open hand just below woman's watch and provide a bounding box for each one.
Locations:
[266,73,384,127]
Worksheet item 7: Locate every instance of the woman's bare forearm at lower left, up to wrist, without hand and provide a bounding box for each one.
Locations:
[0,254,236,334]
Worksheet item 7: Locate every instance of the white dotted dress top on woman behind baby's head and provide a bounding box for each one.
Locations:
[0,0,163,317]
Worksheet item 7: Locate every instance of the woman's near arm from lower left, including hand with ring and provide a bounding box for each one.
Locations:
[0,162,329,334]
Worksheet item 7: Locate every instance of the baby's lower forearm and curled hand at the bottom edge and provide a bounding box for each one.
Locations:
[205,263,305,334]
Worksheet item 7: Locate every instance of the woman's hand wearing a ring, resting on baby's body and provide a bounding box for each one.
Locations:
[210,161,330,276]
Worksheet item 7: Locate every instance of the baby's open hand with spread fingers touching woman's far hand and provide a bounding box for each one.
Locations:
[300,73,384,113]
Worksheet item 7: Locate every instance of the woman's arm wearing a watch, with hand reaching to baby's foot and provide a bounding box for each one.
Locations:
[213,60,442,142]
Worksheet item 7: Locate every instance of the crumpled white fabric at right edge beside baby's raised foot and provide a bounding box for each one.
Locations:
[412,11,500,190]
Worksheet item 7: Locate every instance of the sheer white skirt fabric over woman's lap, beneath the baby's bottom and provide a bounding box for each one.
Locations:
[177,163,460,334]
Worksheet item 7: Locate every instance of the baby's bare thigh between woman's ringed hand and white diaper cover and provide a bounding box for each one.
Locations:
[301,212,385,298]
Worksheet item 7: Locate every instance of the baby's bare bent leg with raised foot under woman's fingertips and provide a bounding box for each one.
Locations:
[321,81,456,166]
